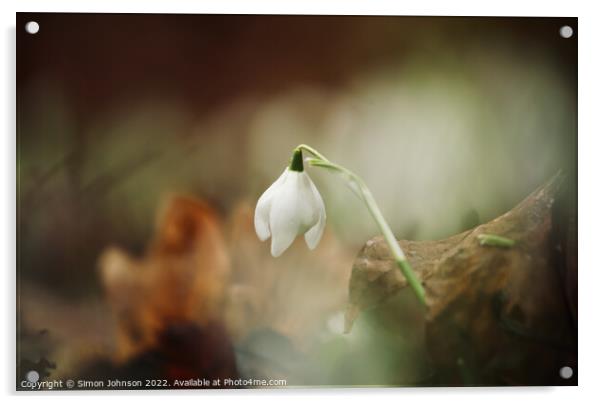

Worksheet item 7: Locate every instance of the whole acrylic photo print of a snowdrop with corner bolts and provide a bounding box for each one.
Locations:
[16,13,578,391]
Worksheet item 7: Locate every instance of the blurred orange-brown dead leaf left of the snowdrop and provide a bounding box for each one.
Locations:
[100,196,230,360]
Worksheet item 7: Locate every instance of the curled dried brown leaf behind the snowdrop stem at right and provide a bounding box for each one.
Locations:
[347,171,576,385]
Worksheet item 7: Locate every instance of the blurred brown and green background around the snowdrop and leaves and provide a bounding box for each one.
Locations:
[17,13,578,385]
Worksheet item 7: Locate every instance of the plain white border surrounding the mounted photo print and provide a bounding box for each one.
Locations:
[0,0,602,404]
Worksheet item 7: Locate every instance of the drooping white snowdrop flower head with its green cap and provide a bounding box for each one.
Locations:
[255,150,326,257]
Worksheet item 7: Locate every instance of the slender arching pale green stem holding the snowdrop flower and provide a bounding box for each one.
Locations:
[295,144,426,305]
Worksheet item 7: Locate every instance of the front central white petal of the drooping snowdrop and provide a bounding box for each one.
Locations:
[270,171,318,257]
